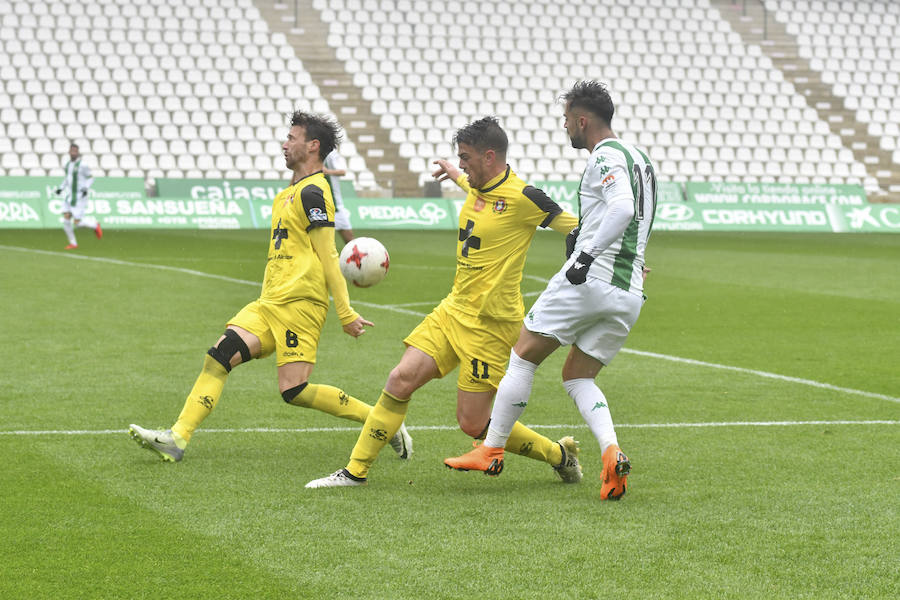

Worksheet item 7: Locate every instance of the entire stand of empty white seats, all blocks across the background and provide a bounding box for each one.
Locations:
[0,0,900,191]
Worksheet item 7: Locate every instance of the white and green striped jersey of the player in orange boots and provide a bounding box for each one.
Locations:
[572,138,656,294]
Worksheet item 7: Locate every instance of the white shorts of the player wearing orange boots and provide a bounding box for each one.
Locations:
[525,271,644,365]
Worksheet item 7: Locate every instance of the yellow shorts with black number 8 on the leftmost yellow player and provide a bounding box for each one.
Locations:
[228,300,328,367]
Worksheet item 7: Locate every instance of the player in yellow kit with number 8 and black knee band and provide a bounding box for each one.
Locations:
[129,111,412,462]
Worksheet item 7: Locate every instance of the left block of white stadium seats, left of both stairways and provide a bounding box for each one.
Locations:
[0,0,376,185]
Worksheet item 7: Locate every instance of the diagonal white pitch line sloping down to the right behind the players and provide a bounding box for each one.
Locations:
[0,244,900,403]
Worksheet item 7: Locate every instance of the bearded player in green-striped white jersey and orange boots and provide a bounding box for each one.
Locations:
[444,81,656,500]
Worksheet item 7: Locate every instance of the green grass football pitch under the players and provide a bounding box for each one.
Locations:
[0,230,900,600]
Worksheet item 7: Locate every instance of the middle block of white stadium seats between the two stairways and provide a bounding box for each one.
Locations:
[313,0,888,190]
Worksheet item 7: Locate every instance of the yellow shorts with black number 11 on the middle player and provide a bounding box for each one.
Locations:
[403,302,522,392]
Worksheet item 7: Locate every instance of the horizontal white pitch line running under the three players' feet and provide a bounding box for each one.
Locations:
[0,420,900,436]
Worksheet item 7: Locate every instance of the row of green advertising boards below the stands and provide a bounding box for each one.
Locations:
[0,176,900,232]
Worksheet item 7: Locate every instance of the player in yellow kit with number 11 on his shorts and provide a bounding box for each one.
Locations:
[306,117,581,488]
